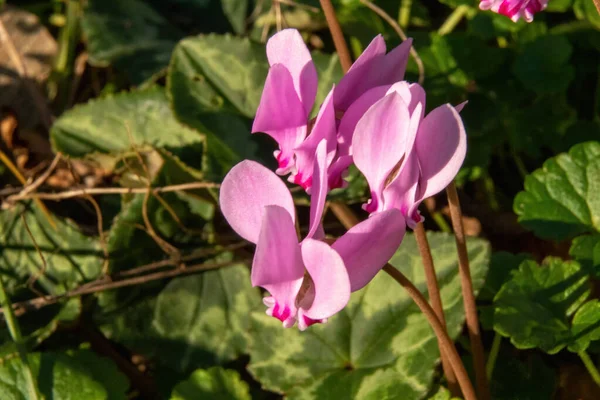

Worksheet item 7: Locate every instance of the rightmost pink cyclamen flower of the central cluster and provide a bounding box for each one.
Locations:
[352,82,467,228]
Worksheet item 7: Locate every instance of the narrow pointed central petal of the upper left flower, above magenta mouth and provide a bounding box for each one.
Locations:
[289,89,336,190]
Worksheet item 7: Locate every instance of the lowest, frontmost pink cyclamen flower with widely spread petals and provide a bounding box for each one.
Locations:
[220,141,405,330]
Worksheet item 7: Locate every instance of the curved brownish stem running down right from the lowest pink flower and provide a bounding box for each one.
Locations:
[383,264,477,400]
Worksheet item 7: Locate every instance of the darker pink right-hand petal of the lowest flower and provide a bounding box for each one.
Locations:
[331,209,406,292]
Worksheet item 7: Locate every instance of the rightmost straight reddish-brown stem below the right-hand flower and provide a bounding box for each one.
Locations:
[446,181,490,400]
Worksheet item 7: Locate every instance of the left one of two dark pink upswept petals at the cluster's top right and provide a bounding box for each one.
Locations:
[334,35,386,111]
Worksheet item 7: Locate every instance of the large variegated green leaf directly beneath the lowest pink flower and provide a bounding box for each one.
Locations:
[248,233,489,400]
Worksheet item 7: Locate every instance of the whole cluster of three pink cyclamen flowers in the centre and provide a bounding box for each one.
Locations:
[220,29,466,330]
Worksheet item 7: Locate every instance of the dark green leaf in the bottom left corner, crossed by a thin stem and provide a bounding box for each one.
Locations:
[0,350,129,400]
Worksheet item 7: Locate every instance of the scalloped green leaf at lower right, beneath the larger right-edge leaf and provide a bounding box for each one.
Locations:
[494,257,590,354]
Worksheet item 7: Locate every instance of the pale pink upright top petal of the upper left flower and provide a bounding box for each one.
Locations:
[267,29,318,116]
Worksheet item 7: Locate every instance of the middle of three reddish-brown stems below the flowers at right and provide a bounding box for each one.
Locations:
[415,222,460,397]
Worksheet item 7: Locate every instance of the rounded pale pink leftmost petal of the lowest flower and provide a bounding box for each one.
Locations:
[219,160,296,243]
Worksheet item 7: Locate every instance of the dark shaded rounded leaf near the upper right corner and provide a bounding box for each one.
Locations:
[512,35,575,94]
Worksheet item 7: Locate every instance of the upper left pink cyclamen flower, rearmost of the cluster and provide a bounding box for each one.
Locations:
[252,29,411,191]
